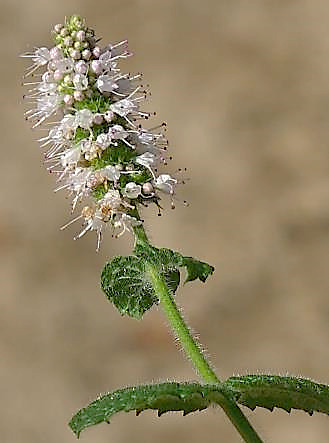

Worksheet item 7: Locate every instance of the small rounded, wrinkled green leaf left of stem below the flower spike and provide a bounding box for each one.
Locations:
[101,256,158,319]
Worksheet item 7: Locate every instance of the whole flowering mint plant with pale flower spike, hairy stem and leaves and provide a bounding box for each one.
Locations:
[23,15,329,443]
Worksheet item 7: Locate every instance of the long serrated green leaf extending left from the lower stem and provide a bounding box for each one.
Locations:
[69,383,220,437]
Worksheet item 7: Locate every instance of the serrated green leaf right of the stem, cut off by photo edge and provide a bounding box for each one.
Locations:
[222,375,329,415]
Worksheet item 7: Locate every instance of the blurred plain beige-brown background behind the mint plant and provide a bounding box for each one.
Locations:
[0,0,329,443]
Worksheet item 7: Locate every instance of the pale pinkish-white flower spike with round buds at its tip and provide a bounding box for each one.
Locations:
[23,15,177,250]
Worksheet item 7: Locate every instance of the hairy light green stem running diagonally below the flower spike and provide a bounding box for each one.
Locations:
[135,226,262,443]
